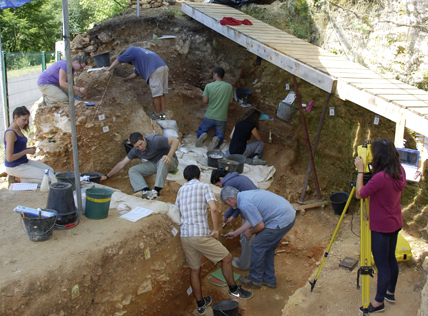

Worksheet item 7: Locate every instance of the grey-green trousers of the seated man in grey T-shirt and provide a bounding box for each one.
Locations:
[128,157,178,192]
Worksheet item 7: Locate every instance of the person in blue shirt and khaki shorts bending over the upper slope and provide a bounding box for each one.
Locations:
[104,46,169,120]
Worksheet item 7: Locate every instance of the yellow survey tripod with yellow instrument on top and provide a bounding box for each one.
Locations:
[309,140,374,315]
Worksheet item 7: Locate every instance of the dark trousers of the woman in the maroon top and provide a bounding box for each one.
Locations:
[372,230,399,303]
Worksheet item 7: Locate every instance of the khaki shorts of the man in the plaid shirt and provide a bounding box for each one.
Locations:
[181,236,229,269]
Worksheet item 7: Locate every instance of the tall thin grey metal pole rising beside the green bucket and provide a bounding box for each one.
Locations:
[62,0,83,215]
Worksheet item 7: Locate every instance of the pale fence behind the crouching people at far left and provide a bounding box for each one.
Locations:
[0,52,60,143]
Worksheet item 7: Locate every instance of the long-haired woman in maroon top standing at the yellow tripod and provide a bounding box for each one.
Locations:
[355,138,406,313]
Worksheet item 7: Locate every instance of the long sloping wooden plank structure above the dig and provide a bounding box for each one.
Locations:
[181,2,428,136]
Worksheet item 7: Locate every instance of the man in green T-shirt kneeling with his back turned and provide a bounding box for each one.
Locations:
[196,67,233,151]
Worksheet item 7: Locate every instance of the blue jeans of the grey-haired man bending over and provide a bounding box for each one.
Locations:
[248,219,296,284]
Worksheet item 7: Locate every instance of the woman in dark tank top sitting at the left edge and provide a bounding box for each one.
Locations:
[4,106,56,183]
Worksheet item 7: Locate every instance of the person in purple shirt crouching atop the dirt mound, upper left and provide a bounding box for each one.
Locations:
[37,56,88,105]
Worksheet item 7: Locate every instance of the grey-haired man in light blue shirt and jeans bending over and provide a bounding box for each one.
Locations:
[220,187,296,288]
